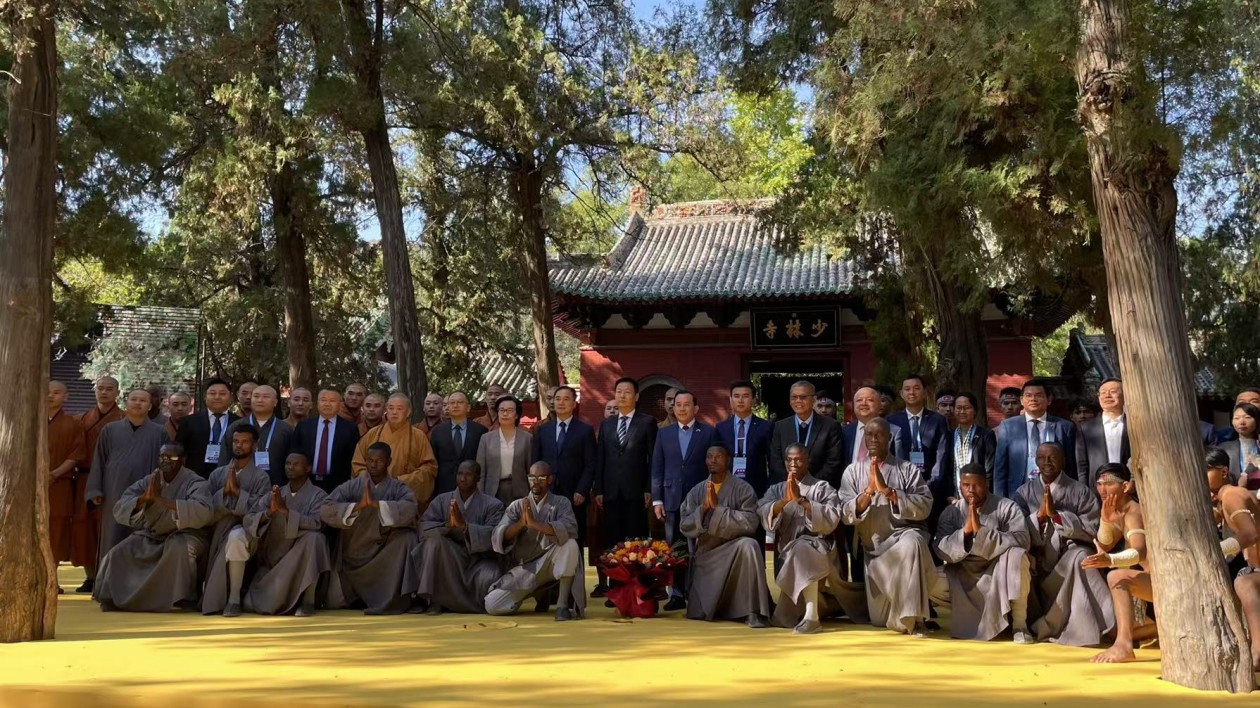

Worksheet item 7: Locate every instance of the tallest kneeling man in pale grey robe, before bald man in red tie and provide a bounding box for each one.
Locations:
[839,418,936,629]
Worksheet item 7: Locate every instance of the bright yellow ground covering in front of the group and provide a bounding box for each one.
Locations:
[0,567,1260,708]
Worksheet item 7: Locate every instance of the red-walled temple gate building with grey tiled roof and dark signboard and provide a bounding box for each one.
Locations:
[551,202,1066,430]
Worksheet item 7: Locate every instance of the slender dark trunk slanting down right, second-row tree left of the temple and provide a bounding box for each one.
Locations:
[341,0,428,410]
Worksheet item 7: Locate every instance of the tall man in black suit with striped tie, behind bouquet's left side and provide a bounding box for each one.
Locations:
[592,377,656,545]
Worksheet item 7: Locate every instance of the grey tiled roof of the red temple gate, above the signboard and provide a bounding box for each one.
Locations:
[551,200,854,302]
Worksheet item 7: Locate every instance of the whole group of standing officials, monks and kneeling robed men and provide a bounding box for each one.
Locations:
[49,377,1260,661]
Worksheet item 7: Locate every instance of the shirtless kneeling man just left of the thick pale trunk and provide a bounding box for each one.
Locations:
[1081,462,1155,664]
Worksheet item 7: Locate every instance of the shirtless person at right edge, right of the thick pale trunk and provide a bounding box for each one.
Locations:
[1206,447,1260,671]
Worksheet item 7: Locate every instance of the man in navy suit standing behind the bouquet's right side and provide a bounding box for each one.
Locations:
[651,391,713,612]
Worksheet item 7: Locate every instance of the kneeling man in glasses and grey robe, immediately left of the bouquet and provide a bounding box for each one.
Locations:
[485,462,586,622]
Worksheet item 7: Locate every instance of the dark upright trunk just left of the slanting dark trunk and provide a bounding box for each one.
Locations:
[267,163,319,391]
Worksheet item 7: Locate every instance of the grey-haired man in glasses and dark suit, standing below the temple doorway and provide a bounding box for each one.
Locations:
[770,380,844,488]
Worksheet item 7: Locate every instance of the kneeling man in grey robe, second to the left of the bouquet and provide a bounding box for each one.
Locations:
[411,460,503,615]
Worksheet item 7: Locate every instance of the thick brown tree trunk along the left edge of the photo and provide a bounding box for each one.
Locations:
[0,0,57,642]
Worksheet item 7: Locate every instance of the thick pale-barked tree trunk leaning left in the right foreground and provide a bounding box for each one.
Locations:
[1076,0,1255,692]
